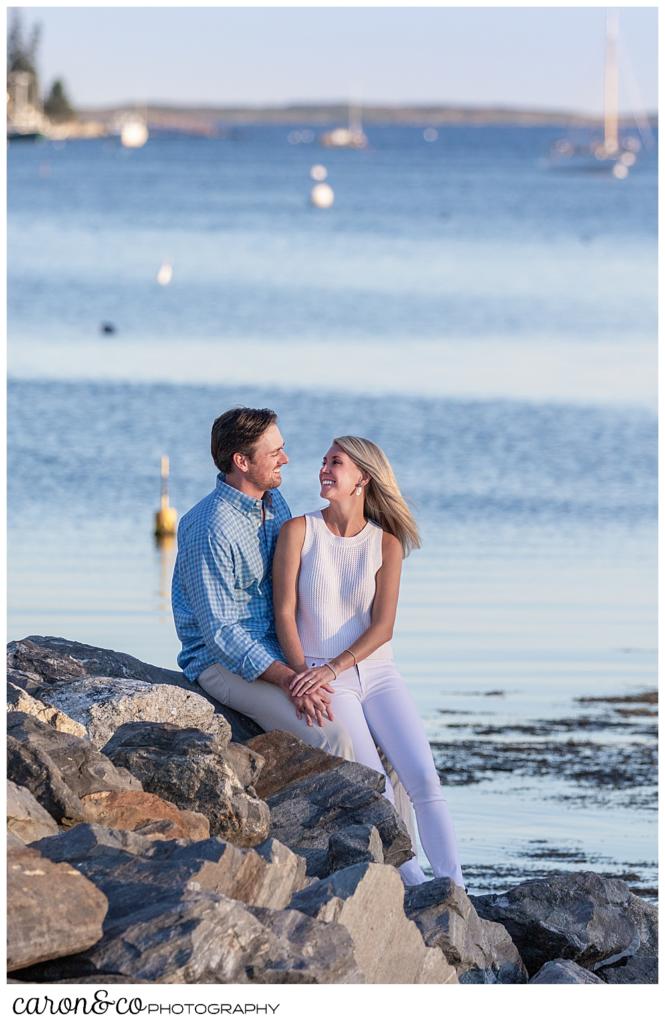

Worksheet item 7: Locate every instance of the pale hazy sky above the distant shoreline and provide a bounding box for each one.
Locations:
[14,6,658,113]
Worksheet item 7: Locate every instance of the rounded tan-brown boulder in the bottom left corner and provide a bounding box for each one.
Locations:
[7,843,108,971]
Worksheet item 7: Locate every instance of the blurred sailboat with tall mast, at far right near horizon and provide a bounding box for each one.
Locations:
[551,11,641,178]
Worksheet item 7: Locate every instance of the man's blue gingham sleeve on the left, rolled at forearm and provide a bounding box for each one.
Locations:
[184,532,275,682]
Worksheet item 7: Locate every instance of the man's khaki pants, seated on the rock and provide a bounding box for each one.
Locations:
[197,663,356,761]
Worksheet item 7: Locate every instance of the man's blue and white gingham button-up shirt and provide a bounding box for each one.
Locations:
[171,473,291,681]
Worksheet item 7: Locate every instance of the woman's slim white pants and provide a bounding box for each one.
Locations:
[305,657,464,886]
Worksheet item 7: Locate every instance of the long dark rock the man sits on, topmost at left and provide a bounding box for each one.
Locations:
[7,636,262,743]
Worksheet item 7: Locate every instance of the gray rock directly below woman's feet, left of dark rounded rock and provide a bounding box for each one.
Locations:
[404,878,528,985]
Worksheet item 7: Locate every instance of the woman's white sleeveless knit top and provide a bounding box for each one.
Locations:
[296,511,392,660]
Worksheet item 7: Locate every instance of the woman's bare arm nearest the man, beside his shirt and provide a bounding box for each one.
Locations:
[273,515,305,672]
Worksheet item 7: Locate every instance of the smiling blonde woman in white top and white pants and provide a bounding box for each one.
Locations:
[273,436,464,886]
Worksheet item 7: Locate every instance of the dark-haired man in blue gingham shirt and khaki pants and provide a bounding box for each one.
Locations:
[171,408,354,760]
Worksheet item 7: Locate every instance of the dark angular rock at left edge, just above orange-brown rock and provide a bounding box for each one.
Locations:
[7,712,141,823]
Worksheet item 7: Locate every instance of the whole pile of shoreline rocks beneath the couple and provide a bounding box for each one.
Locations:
[7,637,658,984]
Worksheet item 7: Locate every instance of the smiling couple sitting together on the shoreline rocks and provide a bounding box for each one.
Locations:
[172,408,464,886]
